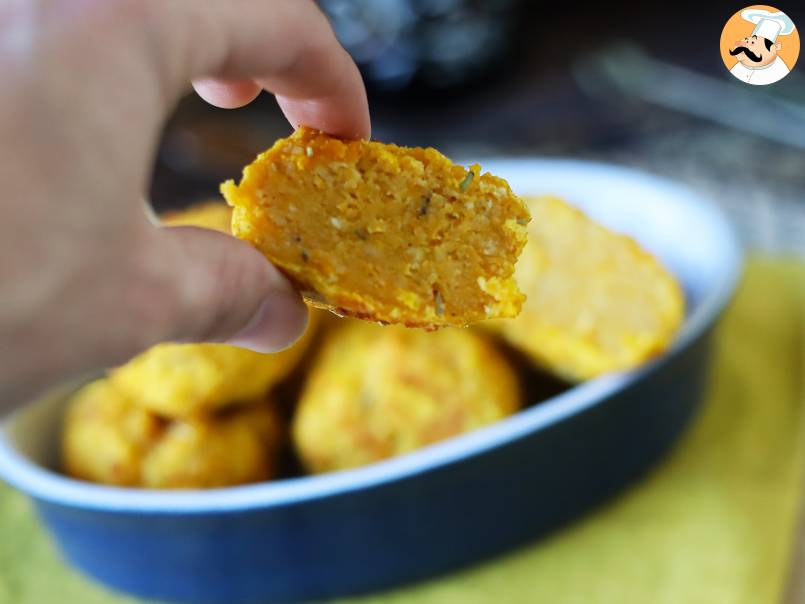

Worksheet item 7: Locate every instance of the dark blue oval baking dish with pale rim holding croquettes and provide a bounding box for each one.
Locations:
[0,159,740,604]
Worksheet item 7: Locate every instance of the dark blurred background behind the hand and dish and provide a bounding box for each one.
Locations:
[152,0,805,254]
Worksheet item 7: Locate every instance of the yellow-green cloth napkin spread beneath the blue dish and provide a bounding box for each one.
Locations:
[0,259,805,604]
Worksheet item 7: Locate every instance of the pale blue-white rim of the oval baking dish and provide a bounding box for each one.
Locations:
[0,158,742,515]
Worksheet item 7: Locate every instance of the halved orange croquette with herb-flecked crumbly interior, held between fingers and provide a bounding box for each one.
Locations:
[221,128,529,328]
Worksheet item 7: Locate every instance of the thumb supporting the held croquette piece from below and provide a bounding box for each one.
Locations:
[152,226,307,352]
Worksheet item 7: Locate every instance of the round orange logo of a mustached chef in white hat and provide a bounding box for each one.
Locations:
[721,5,799,86]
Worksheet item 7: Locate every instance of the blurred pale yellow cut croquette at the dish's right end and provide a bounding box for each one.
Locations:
[489,195,685,381]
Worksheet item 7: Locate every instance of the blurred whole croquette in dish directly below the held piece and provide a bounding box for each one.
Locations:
[292,321,520,472]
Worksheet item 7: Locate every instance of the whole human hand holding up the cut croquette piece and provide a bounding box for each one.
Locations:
[0,0,369,407]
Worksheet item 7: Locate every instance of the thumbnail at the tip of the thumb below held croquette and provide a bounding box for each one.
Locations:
[227,291,308,352]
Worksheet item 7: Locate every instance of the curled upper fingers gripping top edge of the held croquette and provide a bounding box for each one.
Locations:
[154,0,370,138]
